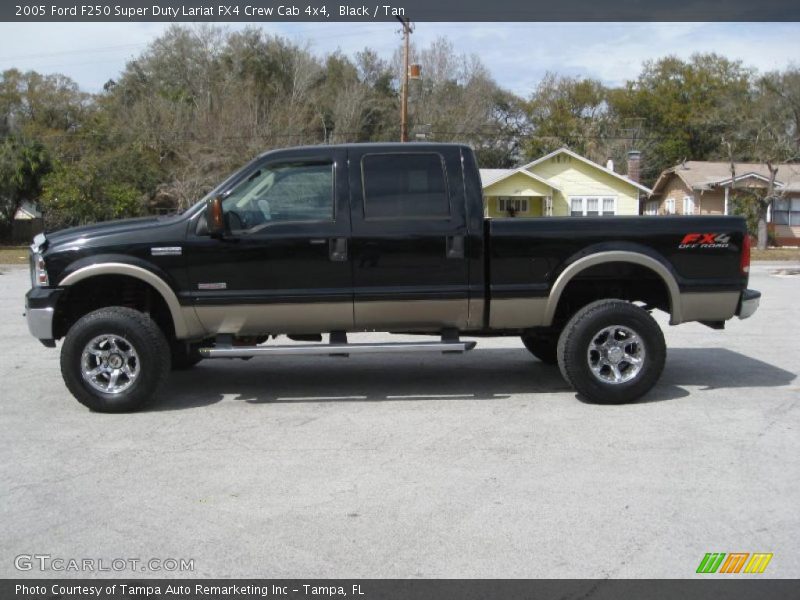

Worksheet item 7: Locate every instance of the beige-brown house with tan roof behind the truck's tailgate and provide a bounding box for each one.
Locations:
[642,161,800,246]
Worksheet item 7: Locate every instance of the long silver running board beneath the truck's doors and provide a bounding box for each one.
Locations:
[200,341,476,358]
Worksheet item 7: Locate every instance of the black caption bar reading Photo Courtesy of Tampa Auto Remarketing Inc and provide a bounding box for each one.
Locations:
[0,576,798,600]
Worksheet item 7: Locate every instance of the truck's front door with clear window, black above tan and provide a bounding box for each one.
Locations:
[186,148,353,335]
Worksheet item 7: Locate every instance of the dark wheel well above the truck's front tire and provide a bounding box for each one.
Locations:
[53,275,175,339]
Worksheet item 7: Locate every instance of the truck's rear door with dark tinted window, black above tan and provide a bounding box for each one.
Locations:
[348,144,469,331]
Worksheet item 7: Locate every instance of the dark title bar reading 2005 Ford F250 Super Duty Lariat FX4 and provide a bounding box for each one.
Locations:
[0,0,800,22]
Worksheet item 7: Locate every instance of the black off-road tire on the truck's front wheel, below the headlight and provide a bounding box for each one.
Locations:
[61,306,170,413]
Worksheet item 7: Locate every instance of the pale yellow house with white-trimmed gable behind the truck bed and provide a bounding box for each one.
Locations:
[481,148,651,217]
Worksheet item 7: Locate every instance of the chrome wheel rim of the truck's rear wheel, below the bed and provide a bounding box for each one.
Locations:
[586,325,646,385]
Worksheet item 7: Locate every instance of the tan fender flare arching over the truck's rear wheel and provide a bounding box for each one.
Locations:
[544,250,682,326]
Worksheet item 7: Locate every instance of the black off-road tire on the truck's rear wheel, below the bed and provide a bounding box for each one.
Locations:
[557,300,667,404]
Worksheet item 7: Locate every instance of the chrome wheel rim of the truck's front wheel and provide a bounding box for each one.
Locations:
[81,334,140,394]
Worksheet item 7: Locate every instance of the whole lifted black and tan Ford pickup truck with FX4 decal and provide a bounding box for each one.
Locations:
[26,144,760,411]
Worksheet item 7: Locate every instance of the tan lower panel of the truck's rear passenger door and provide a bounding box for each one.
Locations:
[355,299,469,331]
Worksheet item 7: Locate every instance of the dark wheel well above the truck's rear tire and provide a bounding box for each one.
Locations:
[553,261,671,327]
